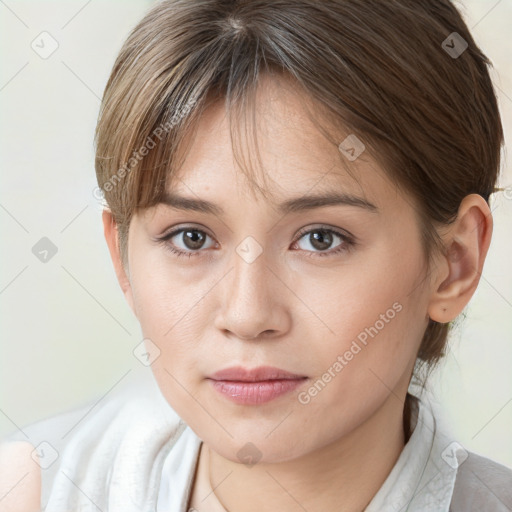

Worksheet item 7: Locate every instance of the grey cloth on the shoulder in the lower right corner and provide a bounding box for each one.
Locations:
[450,452,512,512]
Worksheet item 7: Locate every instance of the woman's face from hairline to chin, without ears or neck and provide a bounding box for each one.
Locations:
[121,75,428,462]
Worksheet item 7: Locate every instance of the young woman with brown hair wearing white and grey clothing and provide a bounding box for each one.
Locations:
[2,0,512,512]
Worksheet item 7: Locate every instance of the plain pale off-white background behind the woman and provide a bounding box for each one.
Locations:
[0,0,512,467]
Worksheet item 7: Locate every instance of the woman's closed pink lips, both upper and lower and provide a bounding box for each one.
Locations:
[208,366,308,405]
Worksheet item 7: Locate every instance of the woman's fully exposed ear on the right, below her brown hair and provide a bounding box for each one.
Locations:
[428,194,493,323]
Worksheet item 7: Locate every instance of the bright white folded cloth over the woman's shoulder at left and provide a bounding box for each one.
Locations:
[0,379,183,512]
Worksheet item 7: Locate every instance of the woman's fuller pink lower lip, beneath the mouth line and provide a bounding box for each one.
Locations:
[209,379,306,404]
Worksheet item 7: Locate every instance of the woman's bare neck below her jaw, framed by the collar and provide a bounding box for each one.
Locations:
[209,394,406,512]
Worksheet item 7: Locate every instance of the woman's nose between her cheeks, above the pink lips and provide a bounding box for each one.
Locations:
[215,247,291,340]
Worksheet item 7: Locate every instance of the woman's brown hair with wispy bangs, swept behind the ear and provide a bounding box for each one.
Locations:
[96,0,503,432]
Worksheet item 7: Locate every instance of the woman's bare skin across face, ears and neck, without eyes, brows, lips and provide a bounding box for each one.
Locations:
[96,74,492,512]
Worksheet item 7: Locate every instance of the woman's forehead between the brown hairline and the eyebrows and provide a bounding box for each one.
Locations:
[167,73,395,208]
